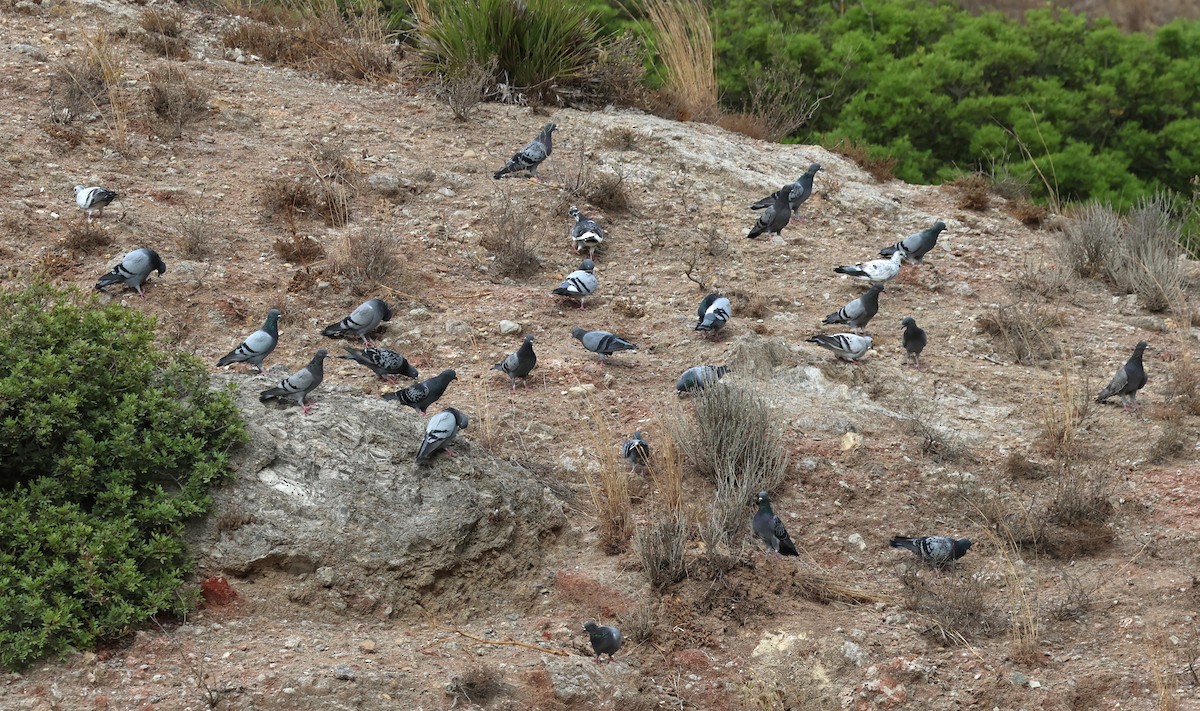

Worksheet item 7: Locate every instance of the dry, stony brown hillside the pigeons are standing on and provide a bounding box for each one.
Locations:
[0,0,1200,711]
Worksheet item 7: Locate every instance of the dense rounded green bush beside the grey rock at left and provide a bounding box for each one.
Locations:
[0,283,245,669]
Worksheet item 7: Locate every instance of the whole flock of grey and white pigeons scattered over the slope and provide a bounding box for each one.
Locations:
[74,123,1147,661]
